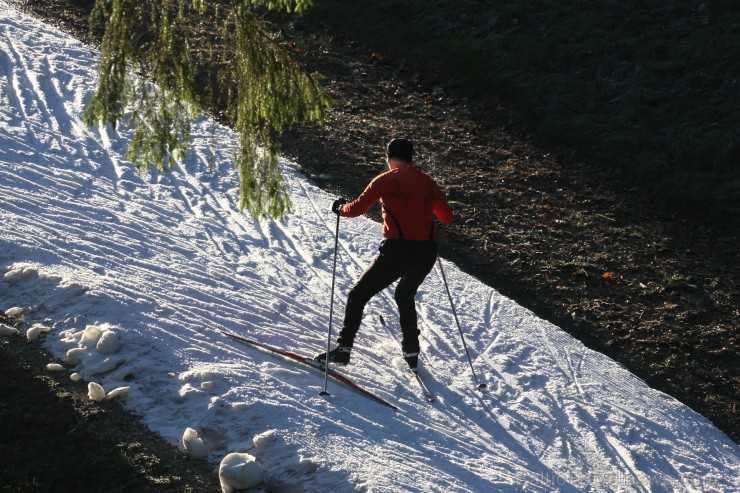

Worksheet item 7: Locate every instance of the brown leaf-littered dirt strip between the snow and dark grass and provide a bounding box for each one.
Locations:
[2,0,740,488]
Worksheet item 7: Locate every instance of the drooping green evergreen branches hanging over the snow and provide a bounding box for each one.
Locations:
[85,0,330,217]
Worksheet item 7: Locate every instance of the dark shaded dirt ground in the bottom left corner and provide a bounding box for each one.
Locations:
[0,313,221,493]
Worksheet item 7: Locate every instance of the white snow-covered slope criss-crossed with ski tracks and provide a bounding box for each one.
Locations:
[0,1,740,493]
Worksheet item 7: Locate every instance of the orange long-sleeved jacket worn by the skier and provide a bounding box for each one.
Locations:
[341,165,452,241]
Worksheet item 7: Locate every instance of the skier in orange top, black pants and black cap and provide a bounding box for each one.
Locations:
[314,139,452,372]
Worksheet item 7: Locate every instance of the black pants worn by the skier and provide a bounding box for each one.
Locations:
[337,240,437,353]
